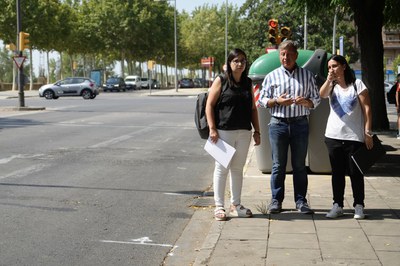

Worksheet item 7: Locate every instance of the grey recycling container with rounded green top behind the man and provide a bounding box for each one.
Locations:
[249,49,331,173]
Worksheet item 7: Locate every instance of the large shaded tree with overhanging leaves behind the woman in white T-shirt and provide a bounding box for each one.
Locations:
[287,0,400,130]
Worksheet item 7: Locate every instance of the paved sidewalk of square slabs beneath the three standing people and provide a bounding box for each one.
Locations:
[165,111,400,266]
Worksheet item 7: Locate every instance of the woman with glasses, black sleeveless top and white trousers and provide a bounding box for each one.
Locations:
[206,49,260,221]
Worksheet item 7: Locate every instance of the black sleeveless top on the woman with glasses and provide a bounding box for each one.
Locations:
[215,77,253,130]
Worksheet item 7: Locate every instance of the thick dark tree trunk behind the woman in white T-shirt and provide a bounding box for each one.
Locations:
[349,0,389,131]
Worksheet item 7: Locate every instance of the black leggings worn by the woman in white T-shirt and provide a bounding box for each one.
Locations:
[325,138,365,207]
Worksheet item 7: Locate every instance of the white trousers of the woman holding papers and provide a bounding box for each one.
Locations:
[213,130,251,207]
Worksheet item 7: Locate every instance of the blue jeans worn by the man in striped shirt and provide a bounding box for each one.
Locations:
[269,116,309,204]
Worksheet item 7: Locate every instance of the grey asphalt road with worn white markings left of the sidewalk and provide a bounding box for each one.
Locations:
[0,92,213,265]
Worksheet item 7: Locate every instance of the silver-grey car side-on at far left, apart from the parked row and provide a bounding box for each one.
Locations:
[39,77,99,100]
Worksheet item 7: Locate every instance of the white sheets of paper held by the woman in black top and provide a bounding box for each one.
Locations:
[204,138,236,168]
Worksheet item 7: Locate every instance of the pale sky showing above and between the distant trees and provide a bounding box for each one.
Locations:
[9,0,246,78]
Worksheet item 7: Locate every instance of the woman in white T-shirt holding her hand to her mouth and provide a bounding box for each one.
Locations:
[320,55,373,219]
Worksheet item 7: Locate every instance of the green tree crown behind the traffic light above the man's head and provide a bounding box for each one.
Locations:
[239,0,358,62]
